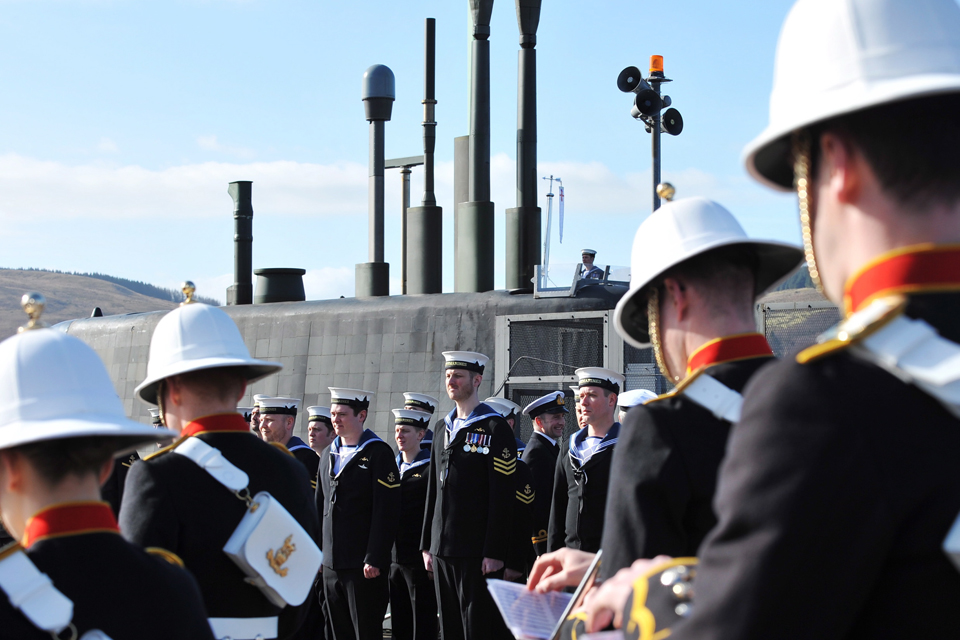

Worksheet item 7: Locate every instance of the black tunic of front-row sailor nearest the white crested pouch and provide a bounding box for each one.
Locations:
[316,429,400,577]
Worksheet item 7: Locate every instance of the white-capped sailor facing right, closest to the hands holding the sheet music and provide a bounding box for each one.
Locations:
[547,367,624,553]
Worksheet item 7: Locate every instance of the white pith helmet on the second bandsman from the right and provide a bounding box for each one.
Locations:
[613,198,803,348]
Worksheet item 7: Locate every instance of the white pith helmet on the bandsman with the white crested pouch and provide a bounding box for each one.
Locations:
[135,303,283,404]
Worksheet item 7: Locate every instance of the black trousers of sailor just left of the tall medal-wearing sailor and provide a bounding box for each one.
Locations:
[390,562,437,640]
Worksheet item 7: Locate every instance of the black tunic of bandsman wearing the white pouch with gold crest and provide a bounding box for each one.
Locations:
[120,413,320,637]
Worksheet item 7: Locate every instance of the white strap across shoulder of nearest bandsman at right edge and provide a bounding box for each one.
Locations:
[851,316,960,417]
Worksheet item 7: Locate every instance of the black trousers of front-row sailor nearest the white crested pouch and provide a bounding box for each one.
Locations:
[323,567,389,640]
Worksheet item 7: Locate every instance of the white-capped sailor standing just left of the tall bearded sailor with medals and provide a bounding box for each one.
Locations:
[390,410,437,640]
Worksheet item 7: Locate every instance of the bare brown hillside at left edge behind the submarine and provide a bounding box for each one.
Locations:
[0,269,177,339]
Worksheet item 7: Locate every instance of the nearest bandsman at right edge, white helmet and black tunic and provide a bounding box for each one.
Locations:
[580,0,960,640]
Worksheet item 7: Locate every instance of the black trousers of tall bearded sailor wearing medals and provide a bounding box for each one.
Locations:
[433,556,513,640]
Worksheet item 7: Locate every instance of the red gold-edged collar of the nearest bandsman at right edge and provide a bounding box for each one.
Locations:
[843,244,960,314]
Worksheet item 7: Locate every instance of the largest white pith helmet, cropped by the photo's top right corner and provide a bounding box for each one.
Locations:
[744,0,960,191]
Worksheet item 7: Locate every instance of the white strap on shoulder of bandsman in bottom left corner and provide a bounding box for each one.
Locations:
[0,549,73,634]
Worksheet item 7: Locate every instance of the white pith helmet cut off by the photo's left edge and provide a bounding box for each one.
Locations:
[0,329,176,451]
